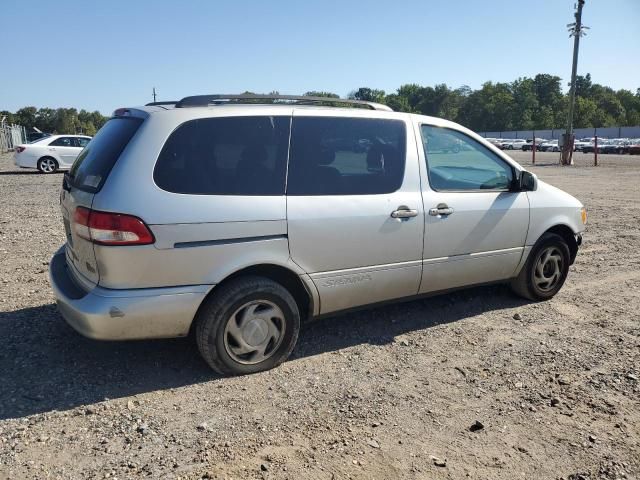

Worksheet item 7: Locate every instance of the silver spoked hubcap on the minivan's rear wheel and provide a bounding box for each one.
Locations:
[224,300,285,365]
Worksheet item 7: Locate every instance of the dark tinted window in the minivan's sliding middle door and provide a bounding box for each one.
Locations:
[287,117,406,195]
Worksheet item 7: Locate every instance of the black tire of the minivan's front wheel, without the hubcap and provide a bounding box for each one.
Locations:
[511,233,571,301]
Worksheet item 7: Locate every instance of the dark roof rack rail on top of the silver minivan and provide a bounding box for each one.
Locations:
[171,93,393,112]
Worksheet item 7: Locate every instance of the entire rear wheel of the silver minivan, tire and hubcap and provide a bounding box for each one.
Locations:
[195,276,300,375]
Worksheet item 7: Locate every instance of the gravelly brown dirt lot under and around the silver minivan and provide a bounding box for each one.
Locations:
[0,153,640,480]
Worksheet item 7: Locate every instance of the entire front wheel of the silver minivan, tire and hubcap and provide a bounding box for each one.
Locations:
[511,233,571,300]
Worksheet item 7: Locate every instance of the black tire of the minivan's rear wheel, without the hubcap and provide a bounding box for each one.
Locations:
[195,276,300,375]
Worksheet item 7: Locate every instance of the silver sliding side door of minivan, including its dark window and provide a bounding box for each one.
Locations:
[287,109,424,313]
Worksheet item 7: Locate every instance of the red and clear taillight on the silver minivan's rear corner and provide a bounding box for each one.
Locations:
[73,207,155,245]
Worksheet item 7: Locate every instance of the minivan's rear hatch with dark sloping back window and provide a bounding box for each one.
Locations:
[60,110,146,286]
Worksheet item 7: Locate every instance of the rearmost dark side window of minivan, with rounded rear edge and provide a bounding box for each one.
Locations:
[153,116,291,195]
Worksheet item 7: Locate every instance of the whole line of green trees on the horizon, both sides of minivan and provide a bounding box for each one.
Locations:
[0,73,640,135]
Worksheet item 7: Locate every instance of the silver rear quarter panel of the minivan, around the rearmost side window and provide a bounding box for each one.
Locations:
[93,106,302,288]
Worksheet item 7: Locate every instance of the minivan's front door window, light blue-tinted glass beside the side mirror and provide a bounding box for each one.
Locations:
[421,125,513,191]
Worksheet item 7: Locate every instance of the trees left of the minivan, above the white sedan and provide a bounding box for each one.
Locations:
[0,107,108,136]
